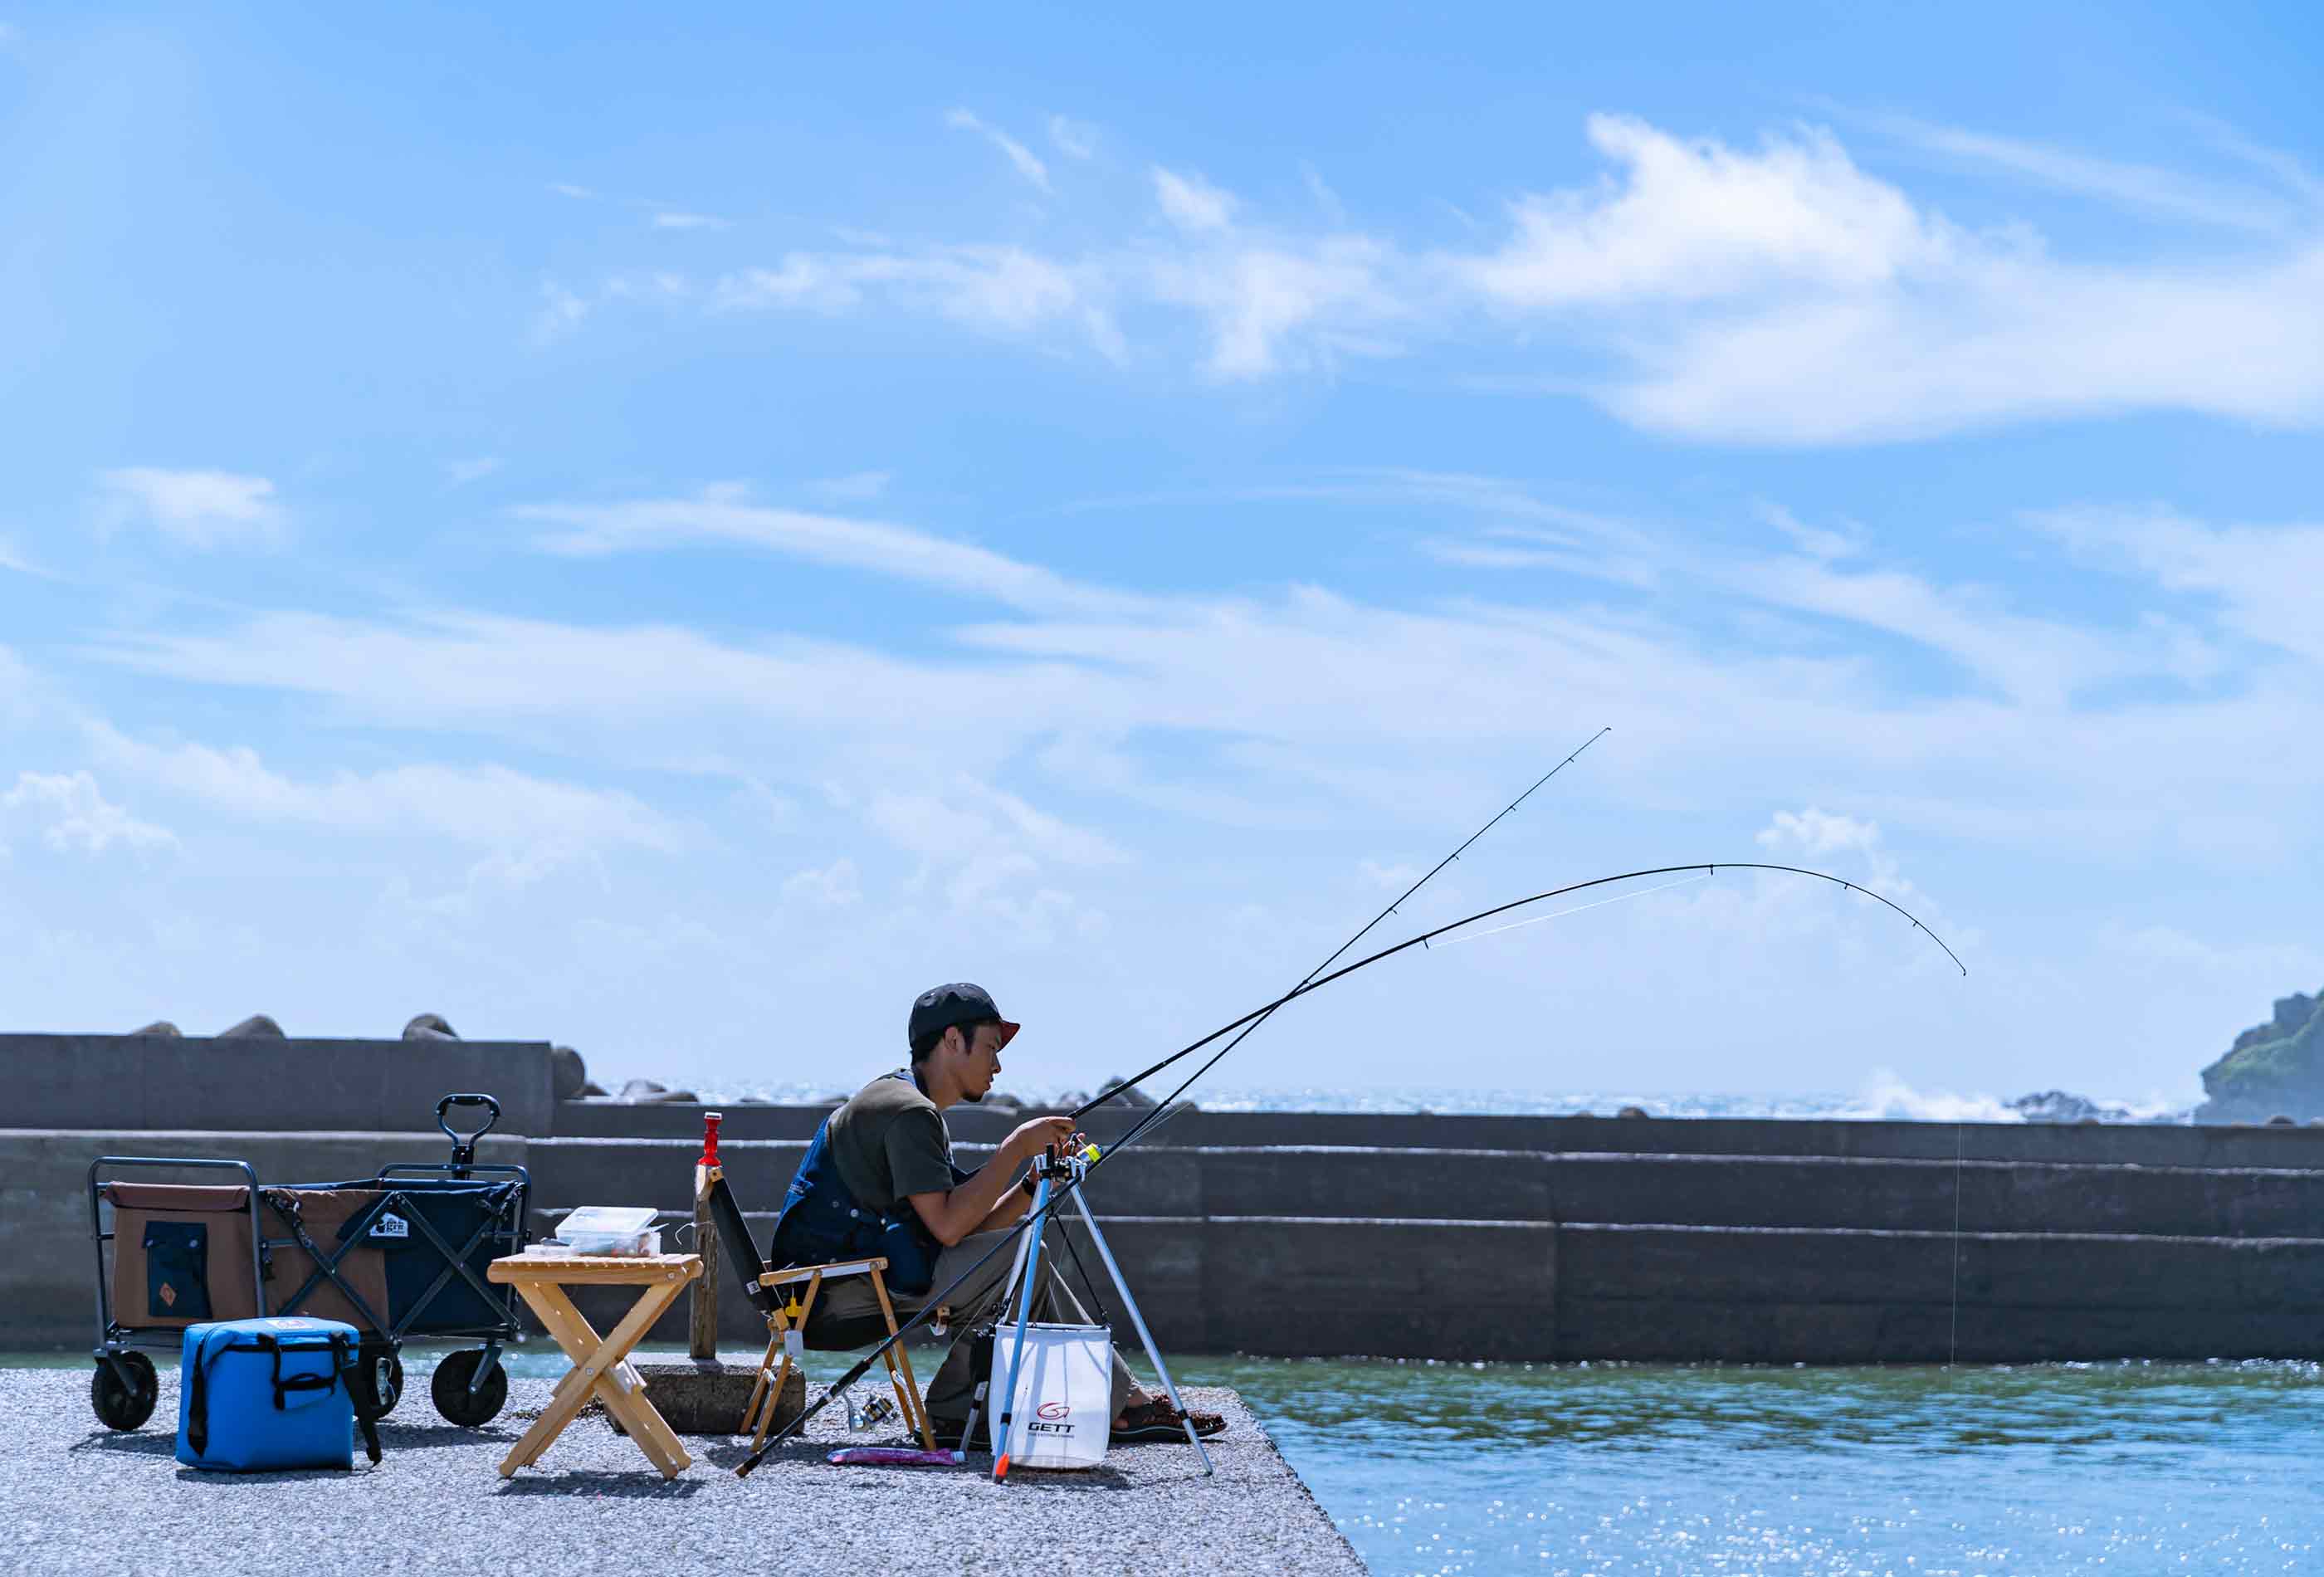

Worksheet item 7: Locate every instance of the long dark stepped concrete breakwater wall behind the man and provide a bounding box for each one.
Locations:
[0,1038,2324,1364]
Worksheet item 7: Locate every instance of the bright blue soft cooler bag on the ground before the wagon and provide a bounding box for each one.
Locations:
[177,1317,378,1472]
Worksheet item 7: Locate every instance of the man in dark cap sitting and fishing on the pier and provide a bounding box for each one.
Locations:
[774,983,1225,1443]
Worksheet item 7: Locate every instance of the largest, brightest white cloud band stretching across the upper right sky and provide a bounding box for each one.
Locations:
[651,111,2324,443]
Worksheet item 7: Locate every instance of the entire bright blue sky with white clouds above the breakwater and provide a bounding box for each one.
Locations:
[0,5,2324,1099]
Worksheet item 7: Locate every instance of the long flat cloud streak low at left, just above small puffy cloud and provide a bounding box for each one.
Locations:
[90,725,681,850]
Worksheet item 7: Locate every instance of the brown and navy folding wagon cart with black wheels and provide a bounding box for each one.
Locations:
[88,1094,532,1431]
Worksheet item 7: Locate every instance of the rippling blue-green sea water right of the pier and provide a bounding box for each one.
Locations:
[1174,1359,2324,1577]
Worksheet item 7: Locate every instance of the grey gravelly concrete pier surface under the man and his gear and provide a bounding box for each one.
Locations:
[0,1368,1365,1577]
